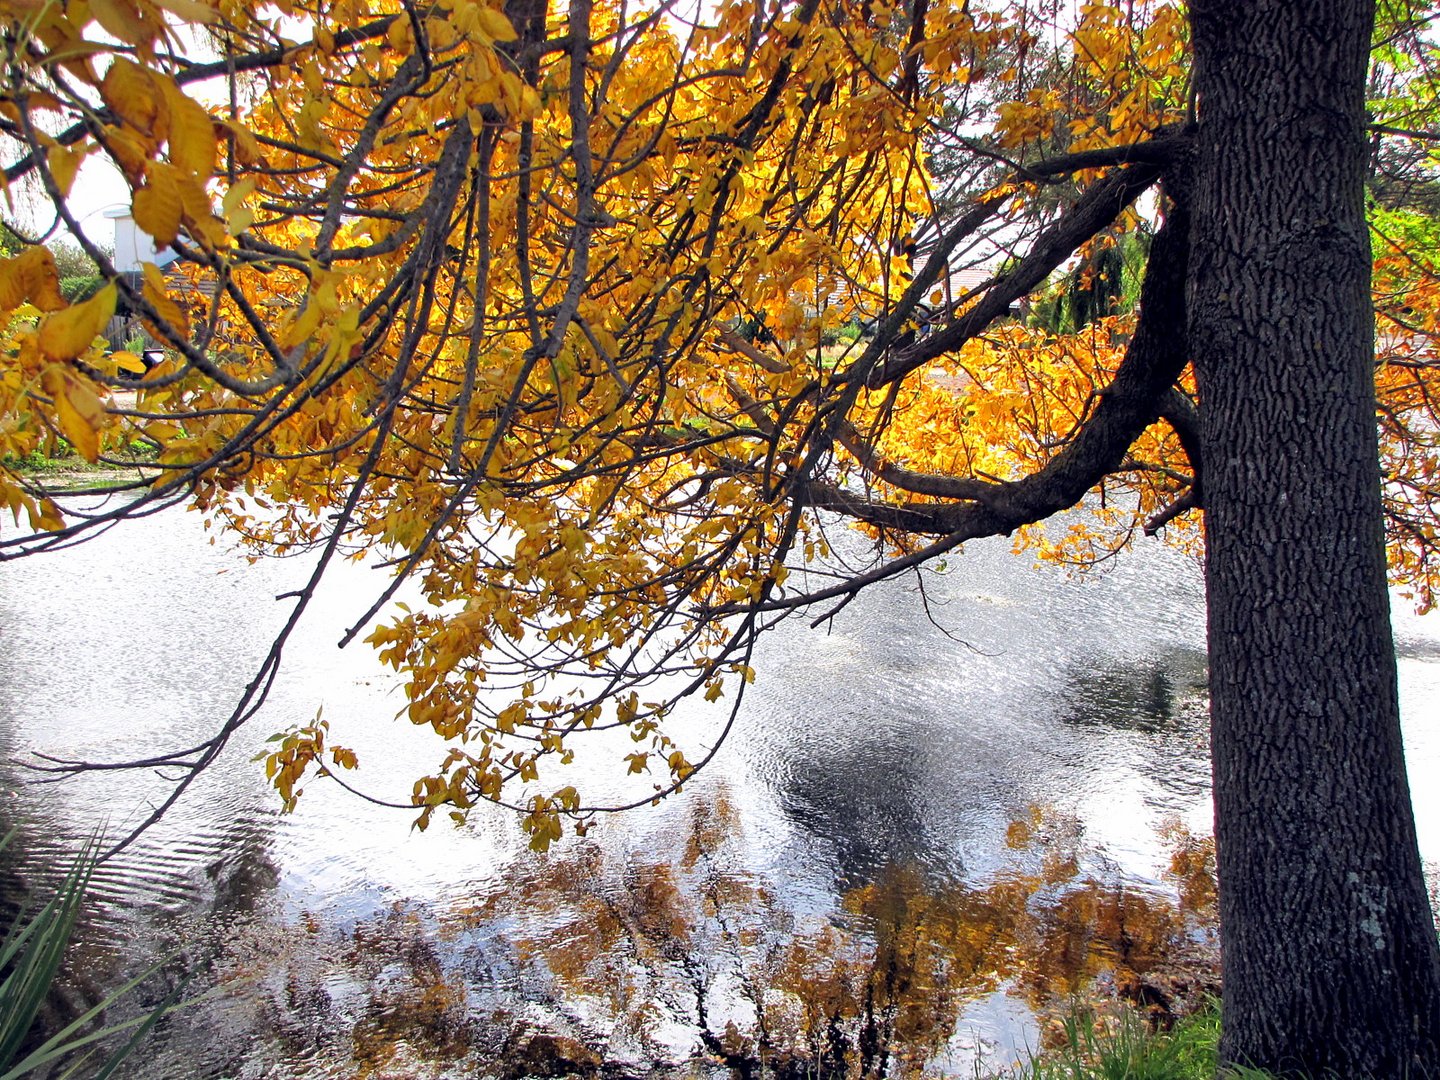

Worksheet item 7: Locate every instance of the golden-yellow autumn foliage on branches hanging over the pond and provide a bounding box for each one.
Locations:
[0,0,1440,848]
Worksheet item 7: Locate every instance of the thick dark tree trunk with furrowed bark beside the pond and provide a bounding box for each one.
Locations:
[1189,0,1440,1077]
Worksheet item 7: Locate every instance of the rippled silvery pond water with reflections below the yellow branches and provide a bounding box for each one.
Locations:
[0,511,1440,1079]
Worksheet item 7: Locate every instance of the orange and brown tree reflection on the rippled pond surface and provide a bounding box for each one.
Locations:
[194,798,1212,1077]
